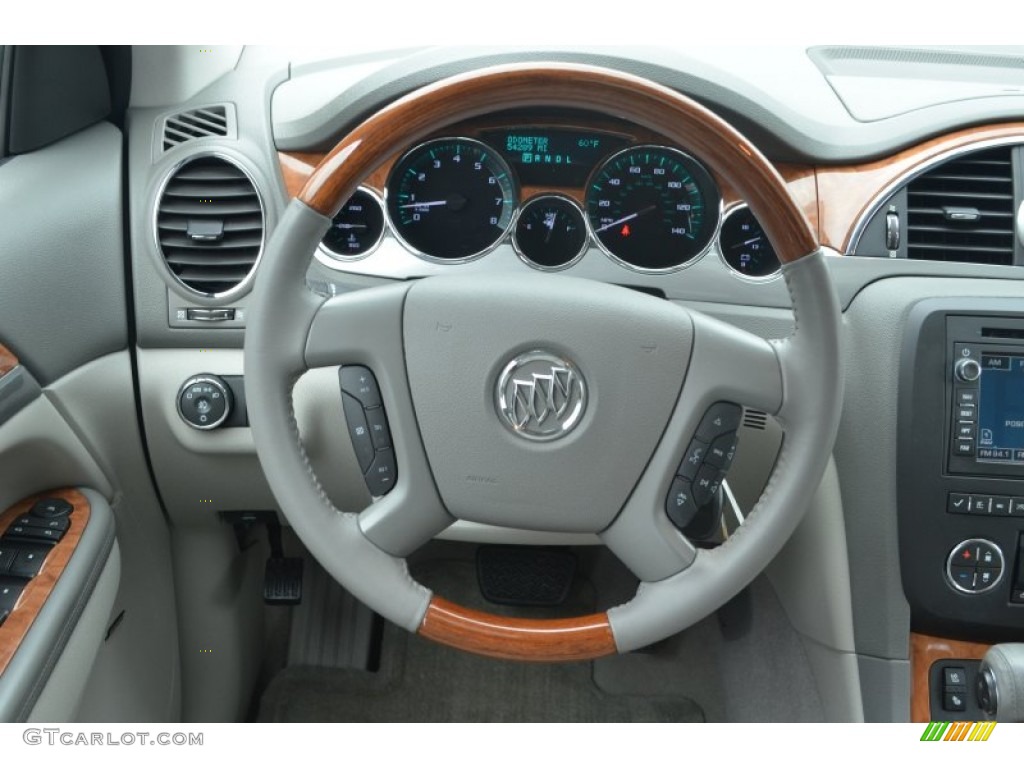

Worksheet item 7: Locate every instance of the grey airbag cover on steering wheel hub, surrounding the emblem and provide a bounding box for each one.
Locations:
[404,275,693,532]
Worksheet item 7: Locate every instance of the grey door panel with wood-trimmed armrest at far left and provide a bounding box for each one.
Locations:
[0,48,180,721]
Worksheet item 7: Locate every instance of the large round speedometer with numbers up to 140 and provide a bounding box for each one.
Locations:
[587,145,721,272]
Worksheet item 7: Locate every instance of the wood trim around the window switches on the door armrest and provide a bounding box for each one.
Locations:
[0,488,90,675]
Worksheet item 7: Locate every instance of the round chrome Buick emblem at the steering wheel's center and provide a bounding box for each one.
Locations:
[496,350,587,440]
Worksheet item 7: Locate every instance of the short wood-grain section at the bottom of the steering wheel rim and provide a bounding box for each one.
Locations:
[420,596,616,662]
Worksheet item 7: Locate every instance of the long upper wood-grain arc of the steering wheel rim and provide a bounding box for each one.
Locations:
[296,63,818,263]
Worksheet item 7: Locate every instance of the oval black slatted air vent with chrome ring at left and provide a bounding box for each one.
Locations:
[157,156,263,296]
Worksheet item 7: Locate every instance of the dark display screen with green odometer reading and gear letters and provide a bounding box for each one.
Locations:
[480,128,628,186]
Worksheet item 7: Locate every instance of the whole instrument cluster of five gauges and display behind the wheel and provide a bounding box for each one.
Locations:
[322,118,778,279]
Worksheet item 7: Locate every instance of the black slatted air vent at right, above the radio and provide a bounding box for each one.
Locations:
[907,146,1014,264]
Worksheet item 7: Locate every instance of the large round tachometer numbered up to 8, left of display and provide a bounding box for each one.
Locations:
[387,138,517,261]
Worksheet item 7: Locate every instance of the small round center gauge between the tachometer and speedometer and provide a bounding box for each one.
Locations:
[512,195,587,270]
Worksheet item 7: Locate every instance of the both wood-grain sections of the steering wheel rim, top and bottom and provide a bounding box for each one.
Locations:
[247,63,831,662]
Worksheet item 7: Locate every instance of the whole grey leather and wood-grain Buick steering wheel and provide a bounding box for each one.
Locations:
[245,63,842,660]
